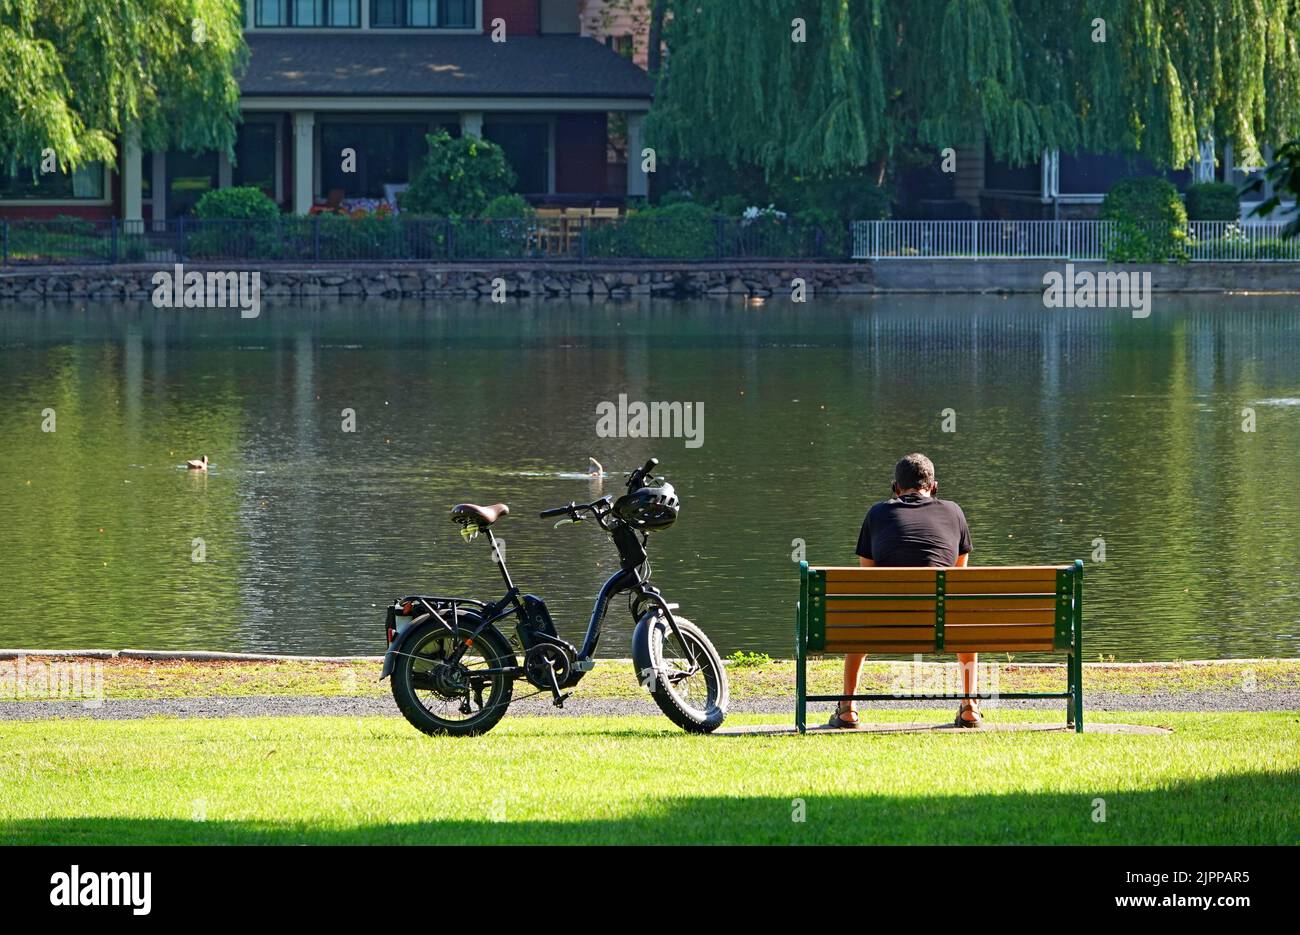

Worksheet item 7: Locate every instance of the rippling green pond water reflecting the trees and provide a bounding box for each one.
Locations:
[0,296,1300,661]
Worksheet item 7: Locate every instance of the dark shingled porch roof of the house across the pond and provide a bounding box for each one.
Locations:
[239,33,654,99]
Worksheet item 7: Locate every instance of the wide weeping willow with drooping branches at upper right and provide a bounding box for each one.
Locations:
[649,0,1300,174]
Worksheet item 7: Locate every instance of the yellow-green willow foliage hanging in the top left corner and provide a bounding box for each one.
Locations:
[0,0,247,170]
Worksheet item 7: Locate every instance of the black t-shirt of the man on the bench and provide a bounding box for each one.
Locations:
[858,494,971,568]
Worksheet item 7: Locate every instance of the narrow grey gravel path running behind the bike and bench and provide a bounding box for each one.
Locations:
[0,692,1300,723]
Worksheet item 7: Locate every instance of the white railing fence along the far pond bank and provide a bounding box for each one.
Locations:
[853,221,1300,263]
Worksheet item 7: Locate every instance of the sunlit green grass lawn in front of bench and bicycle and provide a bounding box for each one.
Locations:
[0,711,1300,844]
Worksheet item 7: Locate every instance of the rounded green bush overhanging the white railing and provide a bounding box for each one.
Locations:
[1101,177,1187,263]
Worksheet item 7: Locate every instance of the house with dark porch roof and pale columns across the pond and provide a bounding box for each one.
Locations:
[0,0,654,221]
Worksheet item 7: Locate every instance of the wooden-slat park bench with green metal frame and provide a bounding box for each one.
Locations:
[794,560,1083,733]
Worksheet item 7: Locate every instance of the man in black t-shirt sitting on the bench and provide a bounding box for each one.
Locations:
[829,453,982,727]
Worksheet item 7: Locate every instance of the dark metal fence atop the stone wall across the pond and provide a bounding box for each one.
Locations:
[0,215,850,267]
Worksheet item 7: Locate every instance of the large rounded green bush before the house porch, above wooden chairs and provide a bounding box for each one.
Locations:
[400,130,516,217]
